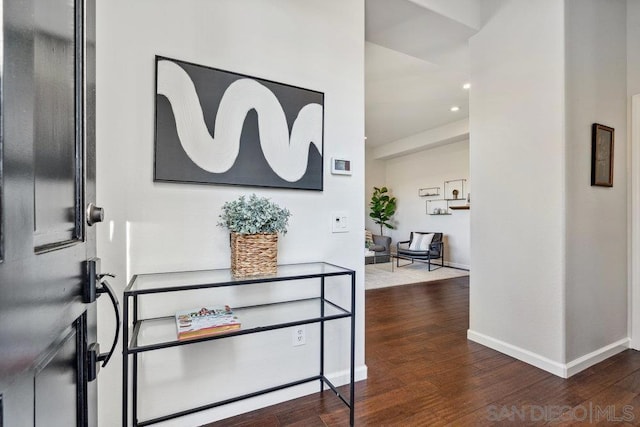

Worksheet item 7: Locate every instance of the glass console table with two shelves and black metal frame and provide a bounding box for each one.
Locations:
[122,262,356,426]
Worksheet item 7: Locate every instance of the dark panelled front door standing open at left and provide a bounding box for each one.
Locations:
[0,0,97,427]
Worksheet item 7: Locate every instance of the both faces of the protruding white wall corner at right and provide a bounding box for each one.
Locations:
[469,0,637,376]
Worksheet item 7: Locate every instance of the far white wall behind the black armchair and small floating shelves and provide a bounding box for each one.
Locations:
[385,141,471,269]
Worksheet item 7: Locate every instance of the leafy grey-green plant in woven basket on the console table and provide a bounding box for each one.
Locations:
[218,194,291,277]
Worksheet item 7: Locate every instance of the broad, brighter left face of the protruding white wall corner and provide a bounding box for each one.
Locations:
[469,0,565,368]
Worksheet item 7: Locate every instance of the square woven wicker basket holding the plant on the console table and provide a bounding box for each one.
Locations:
[231,233,278,277]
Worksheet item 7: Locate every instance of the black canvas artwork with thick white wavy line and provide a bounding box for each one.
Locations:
[154,56,324,190]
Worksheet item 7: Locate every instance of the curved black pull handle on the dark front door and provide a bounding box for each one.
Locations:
[83,258,121,381]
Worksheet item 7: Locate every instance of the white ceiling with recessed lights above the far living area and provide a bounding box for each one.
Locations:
[365,0,501,147]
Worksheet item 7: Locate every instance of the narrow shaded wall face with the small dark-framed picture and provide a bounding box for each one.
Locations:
[565,0,627,363]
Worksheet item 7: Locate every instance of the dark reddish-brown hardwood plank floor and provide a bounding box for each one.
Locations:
[202,277,640,427]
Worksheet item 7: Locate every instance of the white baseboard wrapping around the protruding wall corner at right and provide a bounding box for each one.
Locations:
[467,329,629,378]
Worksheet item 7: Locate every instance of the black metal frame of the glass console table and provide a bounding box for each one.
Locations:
[122,263,356,427]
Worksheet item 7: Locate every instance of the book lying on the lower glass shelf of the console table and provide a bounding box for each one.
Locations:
[176,305,241,341]
